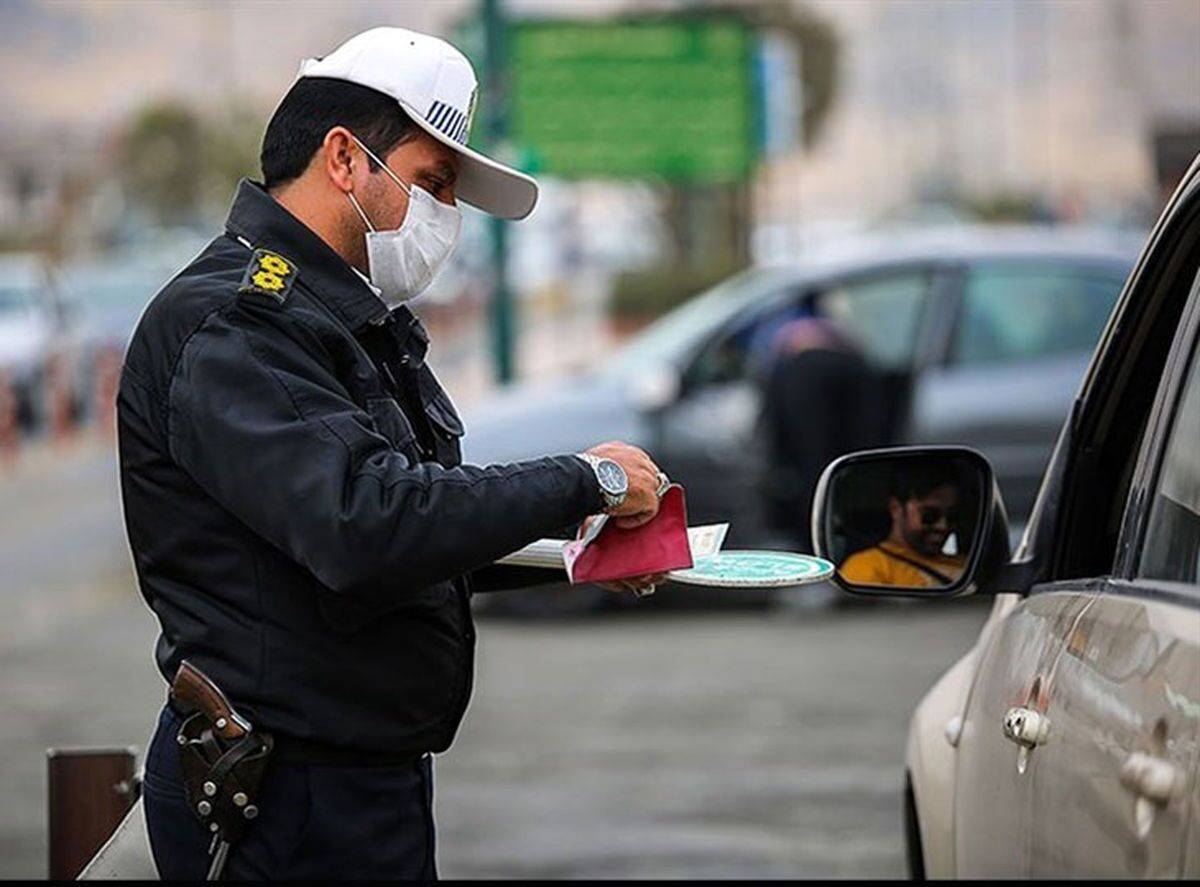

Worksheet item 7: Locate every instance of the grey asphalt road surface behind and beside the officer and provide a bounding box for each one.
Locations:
[0,443,986,877]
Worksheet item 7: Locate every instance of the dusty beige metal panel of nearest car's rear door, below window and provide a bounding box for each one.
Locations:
[1028,585,1200,879]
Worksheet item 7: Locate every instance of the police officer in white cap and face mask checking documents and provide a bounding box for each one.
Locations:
[118,28,661,879]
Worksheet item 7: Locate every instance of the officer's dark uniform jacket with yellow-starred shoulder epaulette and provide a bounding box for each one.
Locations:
[118,181,601,760]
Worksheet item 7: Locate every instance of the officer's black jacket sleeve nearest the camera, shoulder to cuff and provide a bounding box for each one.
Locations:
[167,306,601,599]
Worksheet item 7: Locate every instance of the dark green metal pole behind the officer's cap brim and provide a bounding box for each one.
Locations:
[481,0,516,385]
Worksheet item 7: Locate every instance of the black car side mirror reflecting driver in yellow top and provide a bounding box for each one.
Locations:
[812,447,1009,598]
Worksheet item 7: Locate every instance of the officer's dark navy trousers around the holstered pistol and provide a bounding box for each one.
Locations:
[143,708,437,881]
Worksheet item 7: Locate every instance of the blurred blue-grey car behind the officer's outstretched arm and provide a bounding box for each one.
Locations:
[464,227,1139,610]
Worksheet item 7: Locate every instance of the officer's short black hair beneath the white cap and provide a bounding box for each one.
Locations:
[260,77,419,190]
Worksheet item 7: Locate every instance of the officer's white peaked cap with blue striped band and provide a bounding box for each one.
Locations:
[300,28,538,218]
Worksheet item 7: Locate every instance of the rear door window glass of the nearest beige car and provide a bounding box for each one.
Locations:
[1138,336,1200,585]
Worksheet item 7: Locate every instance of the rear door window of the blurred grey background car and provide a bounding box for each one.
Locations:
[952,265,1124,364]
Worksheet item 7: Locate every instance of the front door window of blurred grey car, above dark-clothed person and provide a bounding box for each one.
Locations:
[817,271,930,370]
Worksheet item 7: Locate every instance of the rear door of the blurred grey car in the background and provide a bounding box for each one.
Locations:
[907,264,1126,526]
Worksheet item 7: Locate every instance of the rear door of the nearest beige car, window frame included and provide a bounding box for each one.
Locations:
[1030,278,1200,879]
